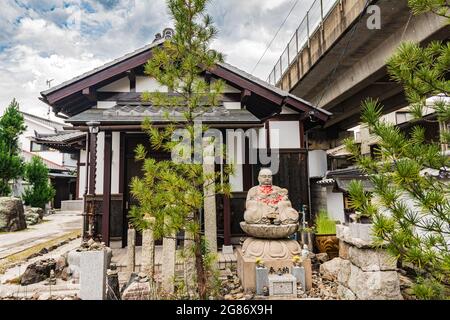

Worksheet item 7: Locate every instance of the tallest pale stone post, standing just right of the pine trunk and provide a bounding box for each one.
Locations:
[203,137,217,253]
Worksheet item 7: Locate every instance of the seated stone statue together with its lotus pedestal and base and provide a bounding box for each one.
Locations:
[236,169,301,291]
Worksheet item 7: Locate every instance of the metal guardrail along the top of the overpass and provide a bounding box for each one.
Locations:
[267,0,341,85]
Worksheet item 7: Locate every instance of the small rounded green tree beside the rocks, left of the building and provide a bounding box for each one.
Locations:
[22,156,56,209]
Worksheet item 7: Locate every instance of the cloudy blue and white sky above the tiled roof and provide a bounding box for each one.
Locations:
[0,0,312,116]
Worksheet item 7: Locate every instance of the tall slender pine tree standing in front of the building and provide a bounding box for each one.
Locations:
[130,0,232,299]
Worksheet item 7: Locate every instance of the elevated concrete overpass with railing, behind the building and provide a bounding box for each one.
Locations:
[268,0,450,132]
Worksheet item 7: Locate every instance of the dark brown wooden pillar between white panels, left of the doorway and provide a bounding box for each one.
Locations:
[102,131,112,246]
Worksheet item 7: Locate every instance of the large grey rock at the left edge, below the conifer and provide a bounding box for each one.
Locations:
[0,197,27,232]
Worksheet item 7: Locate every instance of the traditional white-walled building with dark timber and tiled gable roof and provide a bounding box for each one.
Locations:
[38,28,330,246]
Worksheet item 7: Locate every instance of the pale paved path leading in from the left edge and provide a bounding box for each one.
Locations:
[0,211,82,260]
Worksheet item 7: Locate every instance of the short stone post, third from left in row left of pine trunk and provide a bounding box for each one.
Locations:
[161,218,177,293]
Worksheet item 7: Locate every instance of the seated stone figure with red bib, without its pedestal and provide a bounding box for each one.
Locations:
[244,169,299,225]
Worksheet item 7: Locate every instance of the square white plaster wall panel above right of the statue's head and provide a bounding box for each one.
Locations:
[269,121,300,149]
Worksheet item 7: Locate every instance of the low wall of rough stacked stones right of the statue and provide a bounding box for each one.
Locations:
[336,225,403,300]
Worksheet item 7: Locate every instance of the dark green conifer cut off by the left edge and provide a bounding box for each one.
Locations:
[0,99,26,196]
